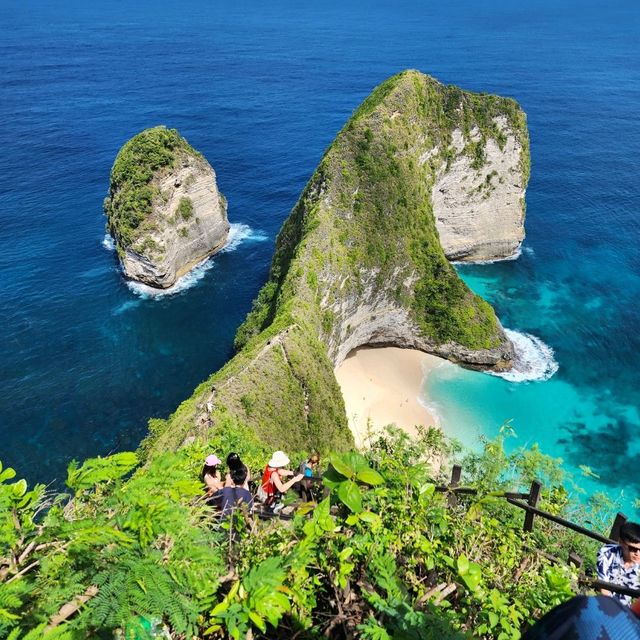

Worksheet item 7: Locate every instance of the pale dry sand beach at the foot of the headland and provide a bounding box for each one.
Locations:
[335,347,442,447]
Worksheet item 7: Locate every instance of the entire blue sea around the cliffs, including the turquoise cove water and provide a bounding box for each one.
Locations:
[0,0,640,512]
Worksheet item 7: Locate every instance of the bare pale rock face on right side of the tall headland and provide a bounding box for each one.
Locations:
[431,116,528,261]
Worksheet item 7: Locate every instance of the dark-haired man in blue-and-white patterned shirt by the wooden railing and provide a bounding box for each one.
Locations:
[597,522,640,606]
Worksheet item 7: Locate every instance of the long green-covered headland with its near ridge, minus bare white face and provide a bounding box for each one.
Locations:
[145,71,528,453]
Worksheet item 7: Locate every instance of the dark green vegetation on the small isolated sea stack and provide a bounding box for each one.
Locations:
[104,126,200,248]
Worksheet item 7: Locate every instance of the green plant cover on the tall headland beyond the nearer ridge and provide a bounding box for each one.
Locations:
[236,71,529,350]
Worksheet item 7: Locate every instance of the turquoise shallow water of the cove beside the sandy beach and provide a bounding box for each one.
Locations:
[424,240,640,516]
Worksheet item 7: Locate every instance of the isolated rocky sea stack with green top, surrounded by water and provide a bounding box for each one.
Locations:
[104,127,229,289]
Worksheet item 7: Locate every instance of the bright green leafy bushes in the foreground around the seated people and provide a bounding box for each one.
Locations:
[0,416,612,640]
